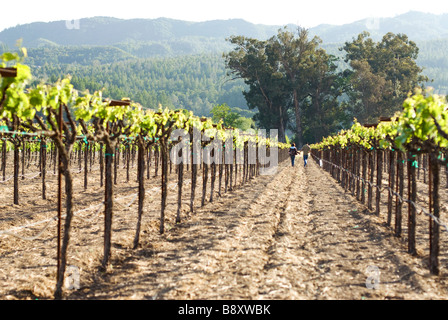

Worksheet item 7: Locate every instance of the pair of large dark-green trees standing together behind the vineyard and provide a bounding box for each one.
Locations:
[224,27,429,146]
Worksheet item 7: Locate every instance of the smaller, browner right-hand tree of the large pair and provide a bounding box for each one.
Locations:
[340,32,428,122]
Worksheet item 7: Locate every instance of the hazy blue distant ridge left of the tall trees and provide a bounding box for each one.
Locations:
[0,16,286,48]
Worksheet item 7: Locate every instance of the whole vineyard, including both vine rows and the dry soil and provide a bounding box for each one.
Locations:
[0,51,448,299]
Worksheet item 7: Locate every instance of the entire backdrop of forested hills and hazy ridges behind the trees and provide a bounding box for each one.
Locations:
[0,12,448,119]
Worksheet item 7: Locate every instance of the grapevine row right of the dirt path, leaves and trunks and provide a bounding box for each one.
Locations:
[312,90,448,274]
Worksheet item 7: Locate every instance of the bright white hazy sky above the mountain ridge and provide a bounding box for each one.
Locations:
[0,0,448,31]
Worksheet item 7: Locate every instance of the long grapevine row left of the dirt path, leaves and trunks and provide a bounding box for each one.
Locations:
[0,50,287,298]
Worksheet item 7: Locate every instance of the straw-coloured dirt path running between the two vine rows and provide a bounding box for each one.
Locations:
[64,161,448,300]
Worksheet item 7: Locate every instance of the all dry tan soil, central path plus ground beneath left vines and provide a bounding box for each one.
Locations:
[0,154,448,300]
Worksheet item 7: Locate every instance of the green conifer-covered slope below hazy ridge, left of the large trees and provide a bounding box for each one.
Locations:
[28,55,246,116]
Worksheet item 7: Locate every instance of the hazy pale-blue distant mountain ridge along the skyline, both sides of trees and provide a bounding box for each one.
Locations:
[0,11,448,48]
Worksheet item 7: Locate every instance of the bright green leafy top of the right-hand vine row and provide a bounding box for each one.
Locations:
[312,90,448,153]
